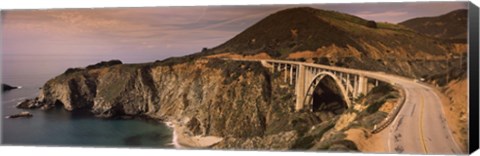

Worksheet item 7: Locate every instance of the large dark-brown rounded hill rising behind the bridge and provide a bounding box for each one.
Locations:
[204,7,467,85]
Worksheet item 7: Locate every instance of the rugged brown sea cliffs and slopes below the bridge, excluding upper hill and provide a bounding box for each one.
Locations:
[17,59,399,151]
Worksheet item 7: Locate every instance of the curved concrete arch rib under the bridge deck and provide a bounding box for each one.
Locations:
[303,71,351,110]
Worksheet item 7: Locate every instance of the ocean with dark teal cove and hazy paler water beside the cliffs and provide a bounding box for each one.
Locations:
[1,55,174,148]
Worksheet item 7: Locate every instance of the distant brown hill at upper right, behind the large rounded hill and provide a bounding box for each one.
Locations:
[399,9,468,42]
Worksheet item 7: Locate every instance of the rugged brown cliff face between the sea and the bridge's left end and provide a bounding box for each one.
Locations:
[37,59,334,141]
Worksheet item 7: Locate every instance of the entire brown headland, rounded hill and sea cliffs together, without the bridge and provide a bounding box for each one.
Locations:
[18,7,466,151]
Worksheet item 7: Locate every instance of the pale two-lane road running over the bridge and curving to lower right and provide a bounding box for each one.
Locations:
[238,60,464,154]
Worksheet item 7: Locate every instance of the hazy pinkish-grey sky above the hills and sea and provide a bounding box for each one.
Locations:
[1,2,467,62]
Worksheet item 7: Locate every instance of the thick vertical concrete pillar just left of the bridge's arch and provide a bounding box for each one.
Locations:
[295,64,305,111]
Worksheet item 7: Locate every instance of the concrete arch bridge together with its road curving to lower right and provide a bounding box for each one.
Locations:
[227,59,466,154]
